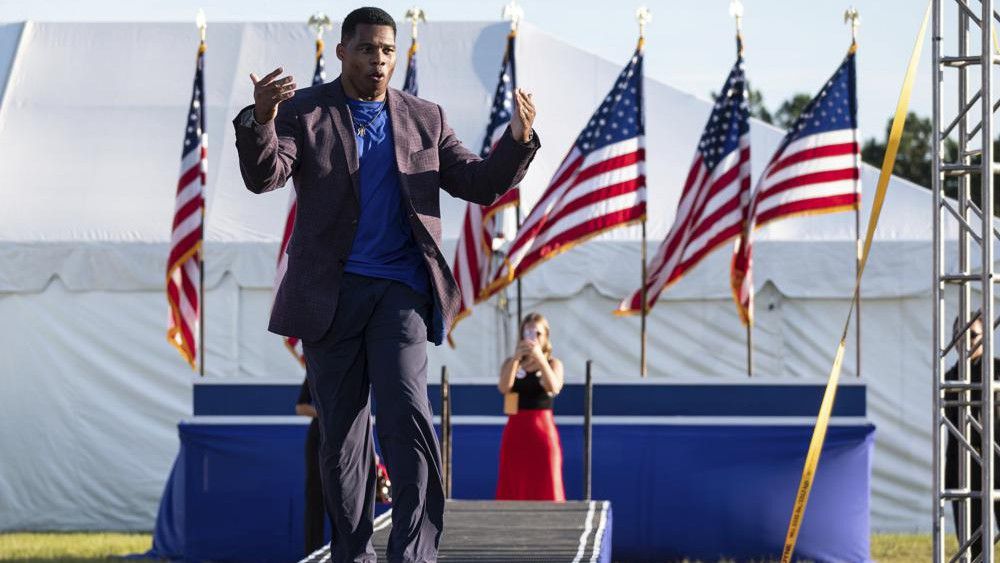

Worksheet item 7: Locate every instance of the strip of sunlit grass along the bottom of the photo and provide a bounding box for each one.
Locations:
[0,532,976,563]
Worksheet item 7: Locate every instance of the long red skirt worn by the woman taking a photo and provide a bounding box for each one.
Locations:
[497,409,566,502]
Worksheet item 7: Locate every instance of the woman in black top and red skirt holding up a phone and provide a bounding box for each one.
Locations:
[497,313,566,501]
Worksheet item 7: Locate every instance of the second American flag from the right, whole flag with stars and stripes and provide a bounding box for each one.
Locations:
[615,49,750,315]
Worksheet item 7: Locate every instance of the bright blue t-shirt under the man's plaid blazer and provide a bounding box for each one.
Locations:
[344,100,430,294]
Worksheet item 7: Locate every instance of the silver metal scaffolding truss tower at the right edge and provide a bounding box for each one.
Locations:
[932,0,1000,562]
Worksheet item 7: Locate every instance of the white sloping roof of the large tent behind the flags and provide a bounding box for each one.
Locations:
[0,22,952,299]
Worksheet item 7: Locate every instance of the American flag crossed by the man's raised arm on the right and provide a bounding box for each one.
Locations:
[448,32,520,346]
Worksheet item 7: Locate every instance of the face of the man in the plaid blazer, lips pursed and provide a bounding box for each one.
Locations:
[337,24,396,100]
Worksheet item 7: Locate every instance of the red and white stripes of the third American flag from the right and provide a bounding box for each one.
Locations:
[487,135,646,295]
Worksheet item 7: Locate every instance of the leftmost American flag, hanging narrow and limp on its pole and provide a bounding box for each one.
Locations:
[167,41,208,369]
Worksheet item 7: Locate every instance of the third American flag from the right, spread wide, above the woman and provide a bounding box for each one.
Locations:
[487,42,646,300]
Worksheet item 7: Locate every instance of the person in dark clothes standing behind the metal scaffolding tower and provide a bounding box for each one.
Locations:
[943,318,1000,559]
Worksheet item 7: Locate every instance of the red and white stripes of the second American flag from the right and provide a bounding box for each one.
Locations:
[615,134,750,315]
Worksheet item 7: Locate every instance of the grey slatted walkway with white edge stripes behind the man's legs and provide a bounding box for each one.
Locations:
[301,500,611,563]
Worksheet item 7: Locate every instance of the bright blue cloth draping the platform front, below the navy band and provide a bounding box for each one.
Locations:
[157,420,874,561]
